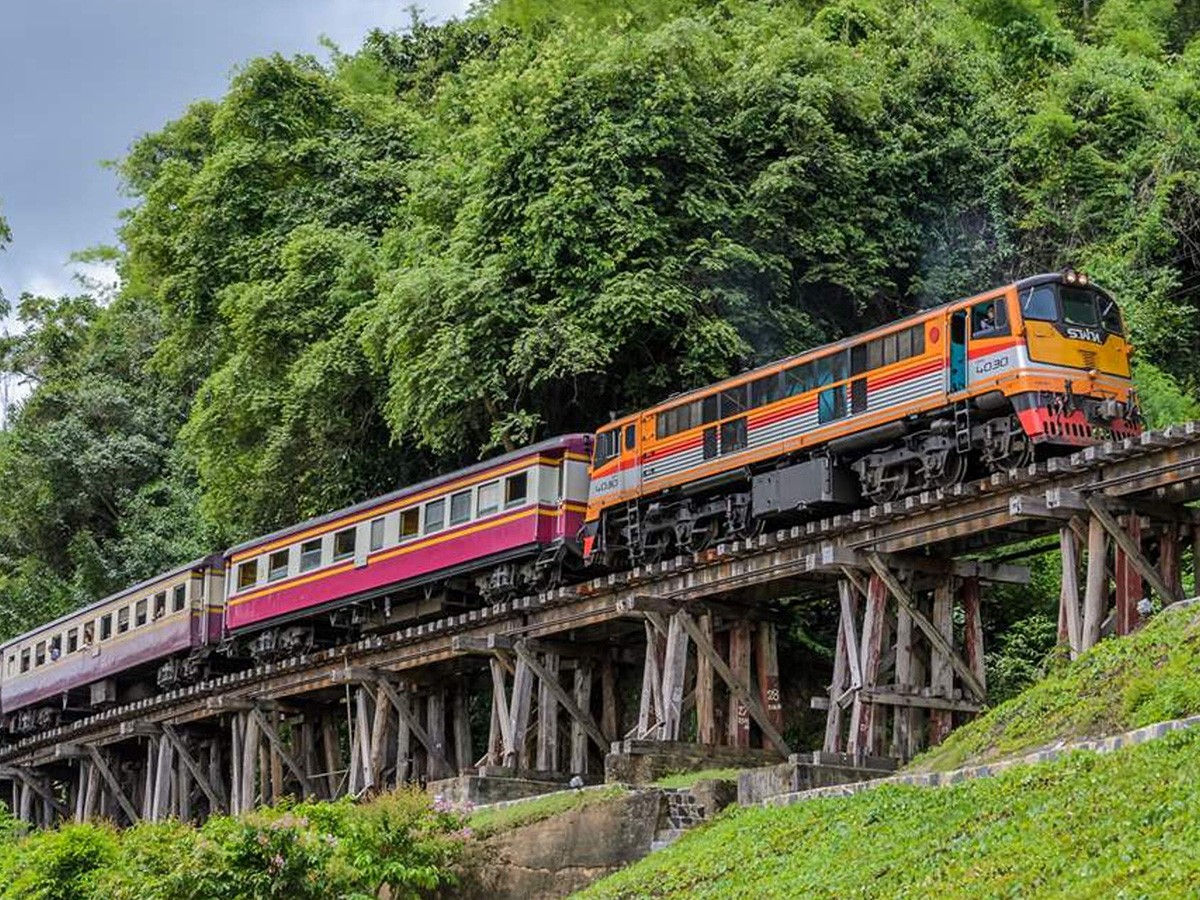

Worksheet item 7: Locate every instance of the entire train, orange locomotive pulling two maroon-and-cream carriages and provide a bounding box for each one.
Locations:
[0,270,1141,739]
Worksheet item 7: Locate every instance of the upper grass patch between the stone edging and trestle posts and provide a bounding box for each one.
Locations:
[908,607,1200,772]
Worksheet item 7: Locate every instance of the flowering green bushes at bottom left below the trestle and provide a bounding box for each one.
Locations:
[0,791,469,900]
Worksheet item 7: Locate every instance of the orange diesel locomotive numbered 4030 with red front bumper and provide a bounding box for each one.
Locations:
[582,271,1140,564]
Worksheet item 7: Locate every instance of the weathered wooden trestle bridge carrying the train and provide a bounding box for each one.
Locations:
[0,422,1200,824]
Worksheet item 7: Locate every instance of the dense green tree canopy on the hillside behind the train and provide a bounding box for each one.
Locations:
[0,0,1200,643]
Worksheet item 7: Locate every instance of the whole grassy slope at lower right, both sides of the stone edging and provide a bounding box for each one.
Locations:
[584,608,1200,898]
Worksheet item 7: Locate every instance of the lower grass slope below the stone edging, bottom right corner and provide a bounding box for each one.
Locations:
[581,730,1200,900]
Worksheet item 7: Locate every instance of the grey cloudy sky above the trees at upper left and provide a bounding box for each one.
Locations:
[0,0,468,301]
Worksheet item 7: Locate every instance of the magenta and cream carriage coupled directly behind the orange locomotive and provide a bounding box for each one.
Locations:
[226,434,592,658]
